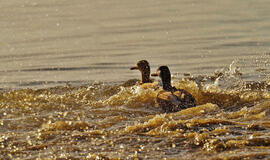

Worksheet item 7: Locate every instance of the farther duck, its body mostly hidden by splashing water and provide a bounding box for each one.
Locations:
[130,60,159,89]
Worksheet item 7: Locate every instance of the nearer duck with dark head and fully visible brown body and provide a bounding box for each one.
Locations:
[151,66,196,112]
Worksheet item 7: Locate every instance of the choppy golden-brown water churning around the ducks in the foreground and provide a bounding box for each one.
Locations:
[0,68,270,159]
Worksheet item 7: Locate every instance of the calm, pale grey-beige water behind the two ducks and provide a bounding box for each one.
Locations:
[0,0,270,88]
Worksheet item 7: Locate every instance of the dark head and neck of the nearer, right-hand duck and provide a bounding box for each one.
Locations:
[151,66,173,91]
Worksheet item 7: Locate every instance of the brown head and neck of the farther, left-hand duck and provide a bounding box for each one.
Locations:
[130,60,152,84]
